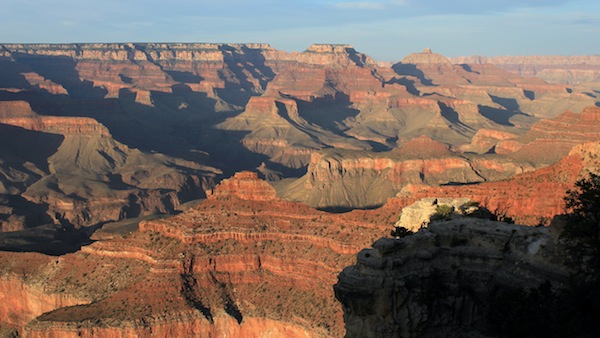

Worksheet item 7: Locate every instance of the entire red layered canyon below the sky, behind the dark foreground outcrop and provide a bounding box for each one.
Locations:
[0,43,600,337]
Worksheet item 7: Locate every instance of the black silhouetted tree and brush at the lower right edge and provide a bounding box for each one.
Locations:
[487,173,600,337]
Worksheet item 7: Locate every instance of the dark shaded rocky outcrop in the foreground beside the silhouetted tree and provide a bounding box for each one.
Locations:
[334,218,569,337]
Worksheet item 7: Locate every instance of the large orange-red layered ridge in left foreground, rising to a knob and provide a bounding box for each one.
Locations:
[0,172,389,337]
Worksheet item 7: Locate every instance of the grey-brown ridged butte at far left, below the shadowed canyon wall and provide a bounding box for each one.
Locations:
[0,103,219,227]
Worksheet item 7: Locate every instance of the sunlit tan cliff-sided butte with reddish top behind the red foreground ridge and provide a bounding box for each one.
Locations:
[276,136,530,210]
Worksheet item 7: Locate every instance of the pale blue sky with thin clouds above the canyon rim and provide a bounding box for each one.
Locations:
[0,0,600,61]
